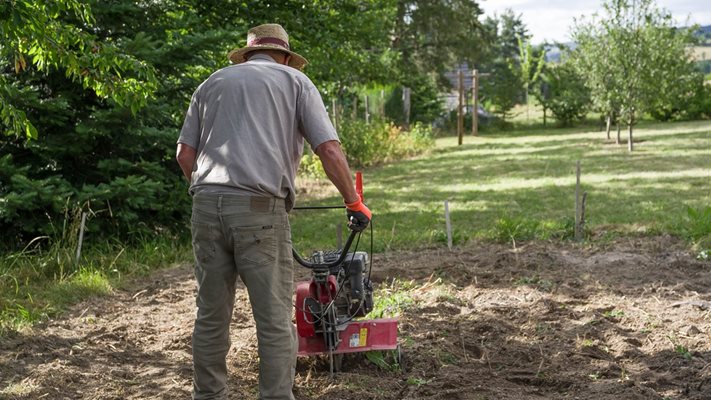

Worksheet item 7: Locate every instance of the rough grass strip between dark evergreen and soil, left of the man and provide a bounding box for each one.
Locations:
[0,234,191,337]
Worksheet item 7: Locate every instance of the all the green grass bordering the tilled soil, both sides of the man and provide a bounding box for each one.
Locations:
[5,119,711,336]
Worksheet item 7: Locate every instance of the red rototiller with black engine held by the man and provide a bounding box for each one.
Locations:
[292,173,401,375]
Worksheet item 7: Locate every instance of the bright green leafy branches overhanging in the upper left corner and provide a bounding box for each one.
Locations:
[0,0,156,139]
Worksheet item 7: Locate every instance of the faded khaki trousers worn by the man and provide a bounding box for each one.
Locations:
[191,193,296,400]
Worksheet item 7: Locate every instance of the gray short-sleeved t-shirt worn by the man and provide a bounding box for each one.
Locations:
[178,54,338,209]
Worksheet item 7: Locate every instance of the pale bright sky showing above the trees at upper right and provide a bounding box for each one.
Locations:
[479,0,711,44]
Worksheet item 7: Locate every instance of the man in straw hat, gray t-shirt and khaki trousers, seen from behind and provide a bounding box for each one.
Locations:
[176,24,371,400]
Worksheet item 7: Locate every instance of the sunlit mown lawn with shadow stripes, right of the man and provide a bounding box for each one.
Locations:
[292,121,711,252]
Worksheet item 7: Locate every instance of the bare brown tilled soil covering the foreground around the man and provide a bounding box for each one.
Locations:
[0,237,711,400]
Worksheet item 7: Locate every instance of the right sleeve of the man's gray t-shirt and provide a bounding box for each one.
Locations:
[298,80,338,150]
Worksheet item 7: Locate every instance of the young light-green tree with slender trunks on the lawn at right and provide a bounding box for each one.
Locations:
[573,0,691,151]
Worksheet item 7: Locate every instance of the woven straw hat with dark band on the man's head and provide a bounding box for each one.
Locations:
[228,24,309,70]
